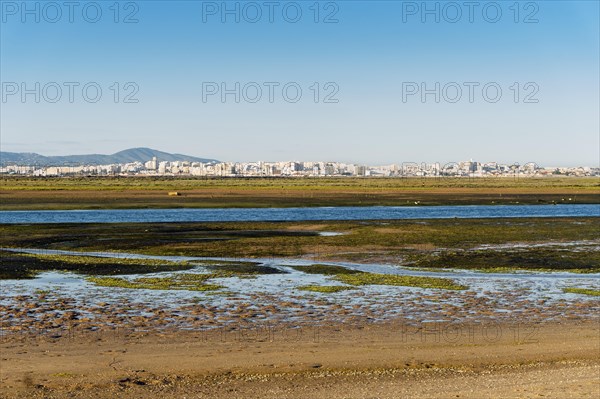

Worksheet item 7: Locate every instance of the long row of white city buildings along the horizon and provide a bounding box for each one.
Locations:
[0,158,600,177]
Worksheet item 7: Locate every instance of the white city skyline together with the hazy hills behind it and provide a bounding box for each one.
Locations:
[0,148,600,178]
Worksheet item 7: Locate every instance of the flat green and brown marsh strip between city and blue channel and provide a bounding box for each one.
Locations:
[0,176,600,210]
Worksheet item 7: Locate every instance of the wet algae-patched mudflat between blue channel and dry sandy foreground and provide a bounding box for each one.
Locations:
[0,218,600,336]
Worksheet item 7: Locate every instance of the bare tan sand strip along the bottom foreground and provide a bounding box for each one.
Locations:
[0,321,600,398]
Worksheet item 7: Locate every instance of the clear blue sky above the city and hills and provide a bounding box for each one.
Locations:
[0,0,600,166]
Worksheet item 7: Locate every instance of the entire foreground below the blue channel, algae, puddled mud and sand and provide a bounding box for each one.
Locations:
[0,217,600,398]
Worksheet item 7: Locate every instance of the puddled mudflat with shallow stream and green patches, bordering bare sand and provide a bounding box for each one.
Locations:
[0,249,600,336]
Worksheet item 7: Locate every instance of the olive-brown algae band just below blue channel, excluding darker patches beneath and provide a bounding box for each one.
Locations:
[0,217,600,266]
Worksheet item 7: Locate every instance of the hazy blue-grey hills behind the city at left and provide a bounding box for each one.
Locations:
[0,148,219,166]
